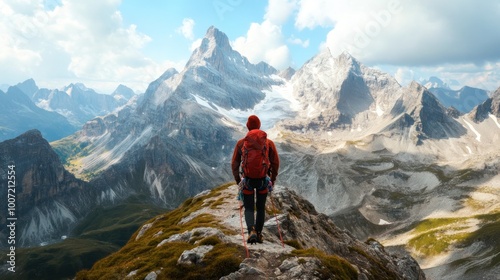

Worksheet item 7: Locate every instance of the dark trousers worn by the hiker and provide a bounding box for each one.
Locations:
[243,180,267,234]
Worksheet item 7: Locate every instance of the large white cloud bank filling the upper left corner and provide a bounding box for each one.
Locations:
[0,0,173,92]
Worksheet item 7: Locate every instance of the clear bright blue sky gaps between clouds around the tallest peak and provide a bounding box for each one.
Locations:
[116,0,329,71]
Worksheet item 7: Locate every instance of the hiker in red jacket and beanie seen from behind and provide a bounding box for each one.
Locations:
[231,115,280,244]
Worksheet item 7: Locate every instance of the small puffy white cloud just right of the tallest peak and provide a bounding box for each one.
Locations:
[233,20,291,69]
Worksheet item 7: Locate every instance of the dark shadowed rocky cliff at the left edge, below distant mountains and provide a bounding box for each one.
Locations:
[0,130,98,247]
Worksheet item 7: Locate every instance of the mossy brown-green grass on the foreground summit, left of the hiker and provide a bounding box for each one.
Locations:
[76,185,244,279]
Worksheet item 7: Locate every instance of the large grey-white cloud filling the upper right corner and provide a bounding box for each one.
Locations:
[295,0,500,66]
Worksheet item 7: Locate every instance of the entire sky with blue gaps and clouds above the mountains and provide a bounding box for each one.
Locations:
[0,0,500,93]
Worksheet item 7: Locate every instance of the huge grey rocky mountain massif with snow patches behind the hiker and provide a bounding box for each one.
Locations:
[2,27,500,279]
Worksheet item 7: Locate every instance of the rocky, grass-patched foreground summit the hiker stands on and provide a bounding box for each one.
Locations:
[76,184,425,280]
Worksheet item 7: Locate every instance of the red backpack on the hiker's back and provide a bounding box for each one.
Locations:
[241,129,271,179]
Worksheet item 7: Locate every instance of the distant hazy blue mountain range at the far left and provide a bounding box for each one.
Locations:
[0,79,139,141]
